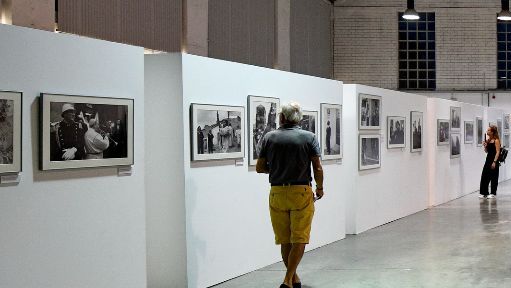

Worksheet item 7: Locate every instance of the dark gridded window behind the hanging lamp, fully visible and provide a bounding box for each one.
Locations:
[398,13,436,90]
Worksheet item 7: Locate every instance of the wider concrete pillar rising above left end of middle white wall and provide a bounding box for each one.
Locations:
[183,0,209,56]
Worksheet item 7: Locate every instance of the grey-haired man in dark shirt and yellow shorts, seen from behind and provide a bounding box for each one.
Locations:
[256,103,323,288]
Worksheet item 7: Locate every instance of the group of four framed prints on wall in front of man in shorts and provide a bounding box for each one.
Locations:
[190,95,342,166]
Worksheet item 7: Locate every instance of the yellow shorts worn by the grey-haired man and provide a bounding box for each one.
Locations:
[270,185,314,245]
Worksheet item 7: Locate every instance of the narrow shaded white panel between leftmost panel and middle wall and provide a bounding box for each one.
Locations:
[144,54,187,288]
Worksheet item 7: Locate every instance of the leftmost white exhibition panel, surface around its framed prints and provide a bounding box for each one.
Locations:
[0,25,146,288]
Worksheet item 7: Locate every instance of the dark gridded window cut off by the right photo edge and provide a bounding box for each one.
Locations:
[497,20,511,89]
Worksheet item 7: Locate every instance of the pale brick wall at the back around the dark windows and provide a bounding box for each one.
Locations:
[334,0,500,90]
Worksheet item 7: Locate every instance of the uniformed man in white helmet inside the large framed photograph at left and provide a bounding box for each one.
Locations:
[50,103,87,161]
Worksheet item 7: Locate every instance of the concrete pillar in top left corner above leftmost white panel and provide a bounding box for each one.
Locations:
[10,0,55,31]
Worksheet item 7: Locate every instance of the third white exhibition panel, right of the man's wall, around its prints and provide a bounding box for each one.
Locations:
[343,85,429,234]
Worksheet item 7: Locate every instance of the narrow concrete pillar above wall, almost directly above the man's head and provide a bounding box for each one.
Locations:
[274,0,291,71]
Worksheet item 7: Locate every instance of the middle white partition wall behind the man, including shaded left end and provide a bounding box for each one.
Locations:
[146,54,349,287]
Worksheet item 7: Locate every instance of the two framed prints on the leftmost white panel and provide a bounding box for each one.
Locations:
[0,92,134,174]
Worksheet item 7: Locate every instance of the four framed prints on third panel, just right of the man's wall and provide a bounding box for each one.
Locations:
[358,93,424,170]
